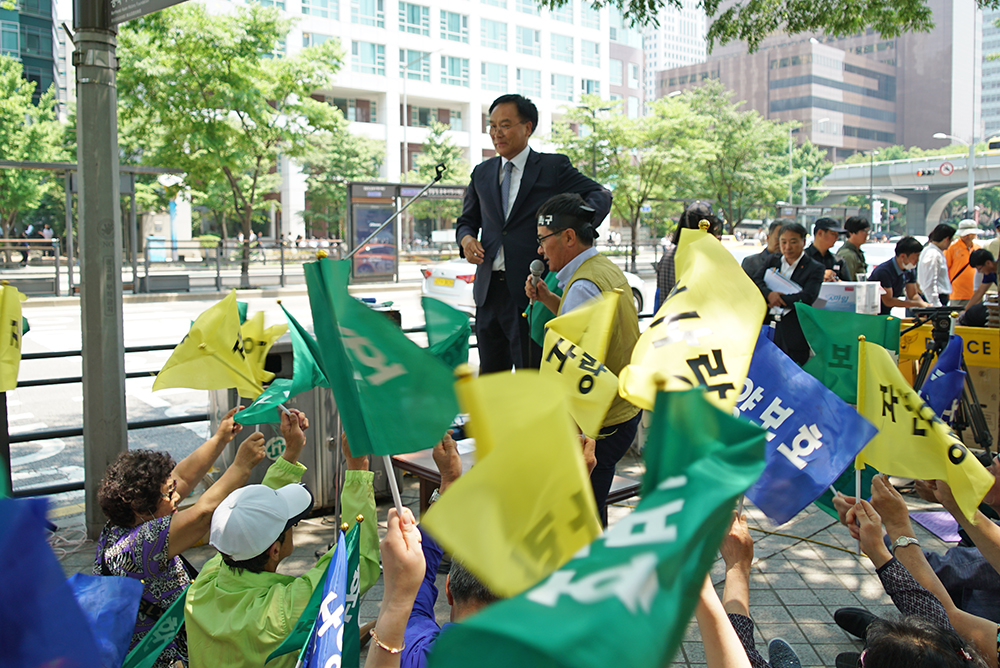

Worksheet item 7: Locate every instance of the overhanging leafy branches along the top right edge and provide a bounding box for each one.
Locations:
[538,0,1000,51]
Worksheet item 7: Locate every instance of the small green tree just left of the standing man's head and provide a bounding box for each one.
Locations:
[406,123,471,236]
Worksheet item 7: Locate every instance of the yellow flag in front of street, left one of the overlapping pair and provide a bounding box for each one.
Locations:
[153,290,264,399]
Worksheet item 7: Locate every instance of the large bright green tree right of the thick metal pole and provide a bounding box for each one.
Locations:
[118,4,345,287]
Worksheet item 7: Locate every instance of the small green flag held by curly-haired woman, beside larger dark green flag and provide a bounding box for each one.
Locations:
[235,302,330,424]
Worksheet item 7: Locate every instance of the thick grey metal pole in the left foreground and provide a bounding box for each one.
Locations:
[73,0,128,538]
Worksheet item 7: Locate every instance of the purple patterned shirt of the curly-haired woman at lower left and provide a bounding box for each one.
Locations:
[94,515,191,668]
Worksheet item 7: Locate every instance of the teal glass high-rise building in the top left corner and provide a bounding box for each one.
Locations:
[0,0,58,102]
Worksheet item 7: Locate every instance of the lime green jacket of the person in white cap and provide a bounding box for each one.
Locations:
[184,459,379,668]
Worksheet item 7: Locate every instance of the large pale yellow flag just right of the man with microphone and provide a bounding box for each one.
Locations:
[618,230,767,412]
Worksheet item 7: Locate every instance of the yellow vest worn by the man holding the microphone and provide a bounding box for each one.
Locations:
[556,254,639,427]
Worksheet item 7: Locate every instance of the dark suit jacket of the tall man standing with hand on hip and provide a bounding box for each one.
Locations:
[455,150,611,311]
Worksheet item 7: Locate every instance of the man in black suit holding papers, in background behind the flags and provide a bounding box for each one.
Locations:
[754,223,826,366]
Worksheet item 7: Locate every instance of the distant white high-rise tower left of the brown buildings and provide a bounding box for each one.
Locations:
[642,0,708,101]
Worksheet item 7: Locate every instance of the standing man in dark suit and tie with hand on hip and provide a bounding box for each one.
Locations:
[455,95,611,373]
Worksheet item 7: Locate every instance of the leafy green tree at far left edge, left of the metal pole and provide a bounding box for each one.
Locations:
[0,56,64,258]
